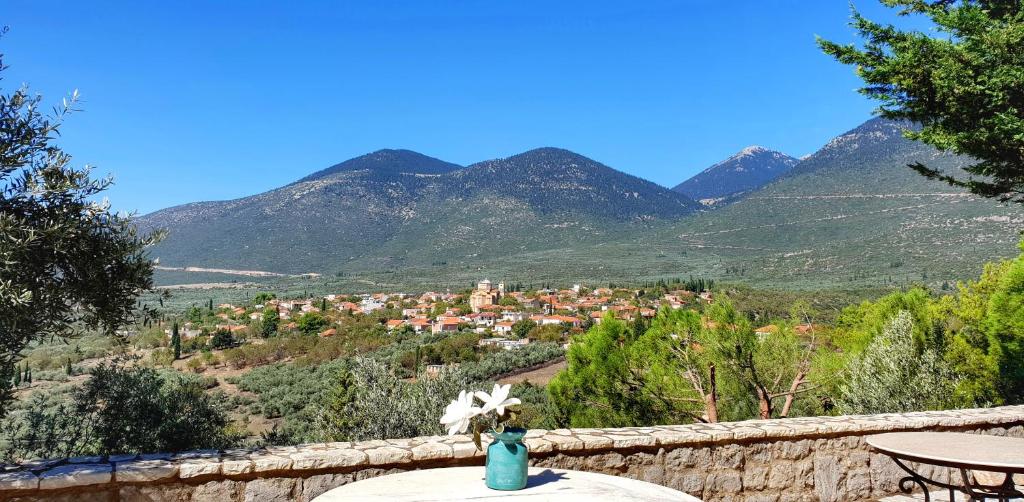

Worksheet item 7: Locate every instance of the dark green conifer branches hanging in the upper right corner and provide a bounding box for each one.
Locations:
[818,0,1024,202]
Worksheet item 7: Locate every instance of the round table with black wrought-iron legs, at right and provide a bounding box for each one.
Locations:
[867,432,1024,501]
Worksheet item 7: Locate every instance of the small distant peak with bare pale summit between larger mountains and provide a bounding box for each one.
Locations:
[672,147,800,206]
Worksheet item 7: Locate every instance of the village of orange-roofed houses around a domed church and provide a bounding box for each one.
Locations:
[176,279,716,349]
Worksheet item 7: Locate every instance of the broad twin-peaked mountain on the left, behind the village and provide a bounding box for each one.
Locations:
[139,149,698,273]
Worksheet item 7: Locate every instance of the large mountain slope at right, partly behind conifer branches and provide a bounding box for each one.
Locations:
[626,119,1024,287]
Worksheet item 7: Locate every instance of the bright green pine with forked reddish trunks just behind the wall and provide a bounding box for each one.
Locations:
[549,303,827,427]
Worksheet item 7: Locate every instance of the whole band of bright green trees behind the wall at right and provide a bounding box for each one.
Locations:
[549,239,1024,427]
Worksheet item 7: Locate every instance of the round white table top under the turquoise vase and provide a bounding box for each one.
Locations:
[313,467,700,502]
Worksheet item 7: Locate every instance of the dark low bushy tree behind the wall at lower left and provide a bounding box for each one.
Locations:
[2,364,238,461]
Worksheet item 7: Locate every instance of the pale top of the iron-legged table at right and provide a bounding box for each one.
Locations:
[867,432,1024,473]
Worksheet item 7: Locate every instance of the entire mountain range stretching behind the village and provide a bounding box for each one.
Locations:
[138,119,1024,288]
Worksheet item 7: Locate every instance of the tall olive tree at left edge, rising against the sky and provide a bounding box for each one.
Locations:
[0,40,159,416]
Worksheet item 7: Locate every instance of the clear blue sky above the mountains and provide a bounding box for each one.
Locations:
[0,0,929,213]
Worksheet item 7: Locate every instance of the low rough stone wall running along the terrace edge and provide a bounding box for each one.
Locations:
[0,406,1024,502]
